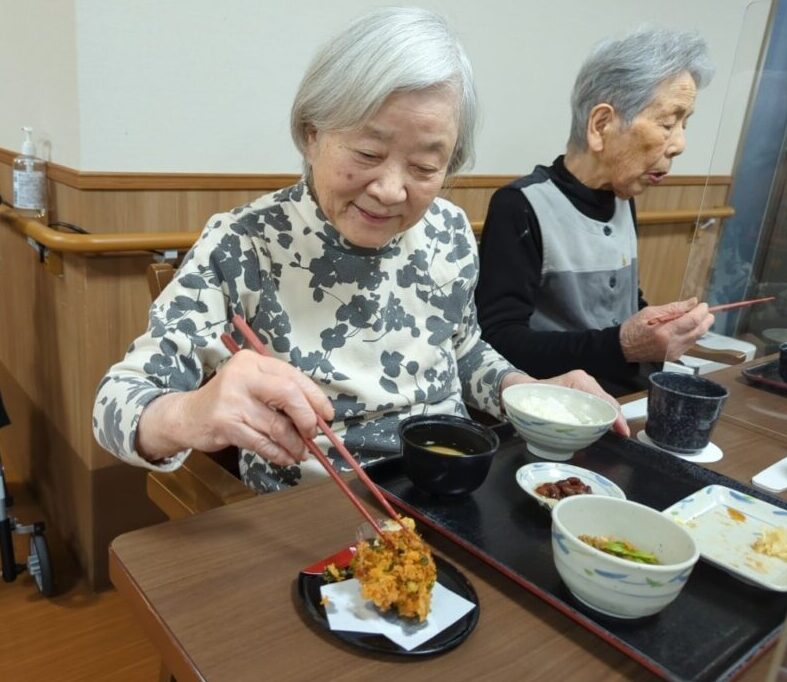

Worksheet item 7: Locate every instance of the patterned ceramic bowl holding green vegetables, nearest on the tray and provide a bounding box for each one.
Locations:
[552,495,700,618]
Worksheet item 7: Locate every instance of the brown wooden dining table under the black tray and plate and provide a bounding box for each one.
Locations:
[110,358,787,682]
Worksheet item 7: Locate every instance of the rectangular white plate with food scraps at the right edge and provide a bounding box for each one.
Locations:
[663,485,787,592]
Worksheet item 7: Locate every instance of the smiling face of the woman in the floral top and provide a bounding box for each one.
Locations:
[306,87,458,248]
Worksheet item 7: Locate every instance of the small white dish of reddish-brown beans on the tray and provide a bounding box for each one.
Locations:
[516,462,626,510]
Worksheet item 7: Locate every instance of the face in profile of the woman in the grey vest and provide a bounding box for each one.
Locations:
[589,72,697,199]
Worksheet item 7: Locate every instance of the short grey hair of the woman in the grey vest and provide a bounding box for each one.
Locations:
[568,27,715,151]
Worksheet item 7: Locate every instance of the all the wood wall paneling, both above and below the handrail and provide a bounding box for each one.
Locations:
[0,150,729,587]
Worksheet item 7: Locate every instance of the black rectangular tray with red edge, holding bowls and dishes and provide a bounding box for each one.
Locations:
[366,425,787,682]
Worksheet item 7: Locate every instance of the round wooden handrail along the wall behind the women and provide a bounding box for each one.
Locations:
[0,205,735,253]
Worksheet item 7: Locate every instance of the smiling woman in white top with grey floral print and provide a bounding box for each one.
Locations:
[94,8,627,492]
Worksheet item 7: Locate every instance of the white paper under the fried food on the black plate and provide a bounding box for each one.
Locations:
[320,579,475,651]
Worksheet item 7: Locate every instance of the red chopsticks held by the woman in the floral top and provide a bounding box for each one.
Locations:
[221,315,409,543]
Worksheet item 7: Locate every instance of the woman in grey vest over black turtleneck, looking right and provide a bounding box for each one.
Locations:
[476,28,713,395]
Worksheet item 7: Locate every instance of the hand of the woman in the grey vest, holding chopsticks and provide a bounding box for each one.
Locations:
[620,298,715,362]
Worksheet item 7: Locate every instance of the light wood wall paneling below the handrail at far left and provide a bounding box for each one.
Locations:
[0,214,163,588]
